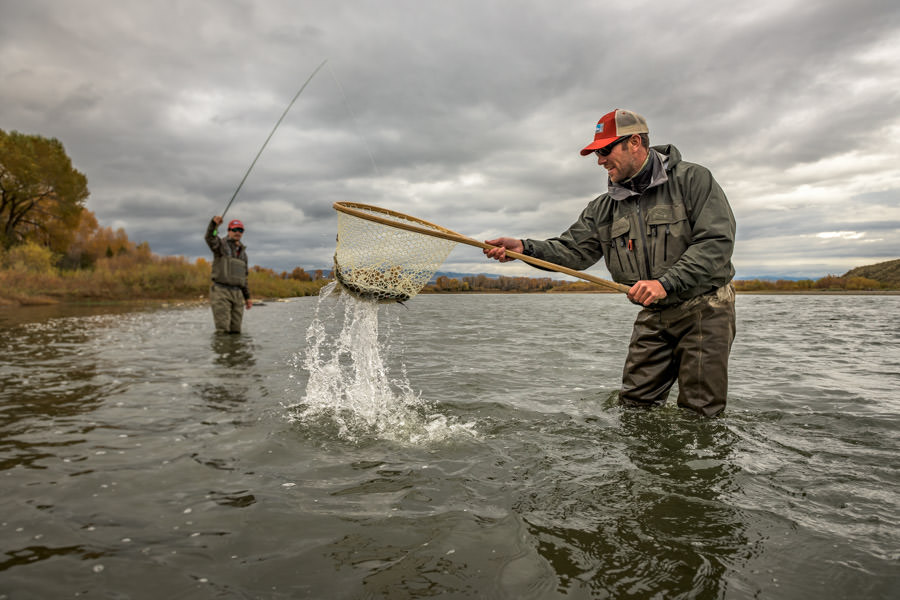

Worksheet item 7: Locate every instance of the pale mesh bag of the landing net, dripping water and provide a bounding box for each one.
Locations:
[334,204,456,302]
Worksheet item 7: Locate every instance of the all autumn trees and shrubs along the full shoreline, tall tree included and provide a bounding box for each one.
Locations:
[0,129,900,307]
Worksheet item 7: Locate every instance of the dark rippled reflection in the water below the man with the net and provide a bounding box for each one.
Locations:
[506,408,758,598]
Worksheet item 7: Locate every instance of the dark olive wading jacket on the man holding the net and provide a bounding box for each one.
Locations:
[522,145,735,307]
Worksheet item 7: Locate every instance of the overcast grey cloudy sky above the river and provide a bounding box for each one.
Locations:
[0,0,900,278]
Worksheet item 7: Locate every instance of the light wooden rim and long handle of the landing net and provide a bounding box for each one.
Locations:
[333,202,631,294]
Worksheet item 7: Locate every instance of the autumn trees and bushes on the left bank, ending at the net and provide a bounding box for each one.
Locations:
[0,129,330,304]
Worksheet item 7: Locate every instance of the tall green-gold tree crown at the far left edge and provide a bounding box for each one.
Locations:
[0,129,89,253]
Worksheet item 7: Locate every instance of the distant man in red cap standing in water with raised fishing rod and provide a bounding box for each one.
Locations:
[206,216,253,333]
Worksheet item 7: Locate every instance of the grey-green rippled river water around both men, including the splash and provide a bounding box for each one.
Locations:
[0,294,900,600]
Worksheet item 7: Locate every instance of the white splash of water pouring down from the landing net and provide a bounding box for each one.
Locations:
[288,283,475,444]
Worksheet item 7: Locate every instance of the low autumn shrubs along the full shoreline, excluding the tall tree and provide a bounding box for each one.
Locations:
[0,237,900,307]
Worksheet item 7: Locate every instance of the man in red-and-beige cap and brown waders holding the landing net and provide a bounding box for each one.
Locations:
[484,109,735,417]
